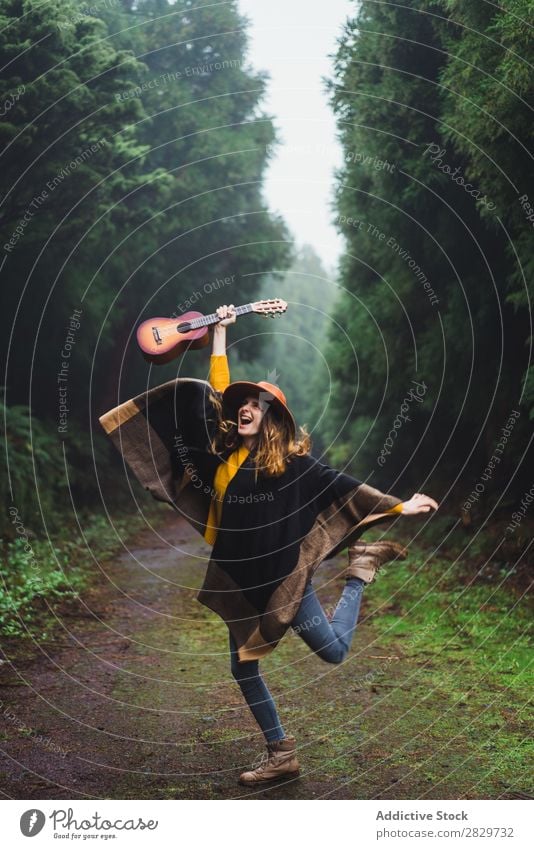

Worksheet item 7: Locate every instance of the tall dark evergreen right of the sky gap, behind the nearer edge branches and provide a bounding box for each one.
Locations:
[328,3,527,501]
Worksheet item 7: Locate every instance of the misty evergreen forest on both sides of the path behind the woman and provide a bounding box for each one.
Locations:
[0,0,534,617]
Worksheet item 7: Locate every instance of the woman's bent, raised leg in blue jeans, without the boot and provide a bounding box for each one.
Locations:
[291,578,365,663]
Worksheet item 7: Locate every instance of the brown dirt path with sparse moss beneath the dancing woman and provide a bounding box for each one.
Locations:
[0,517,525,799]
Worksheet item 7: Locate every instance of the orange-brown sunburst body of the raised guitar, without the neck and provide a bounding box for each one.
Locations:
[137,312,209,365]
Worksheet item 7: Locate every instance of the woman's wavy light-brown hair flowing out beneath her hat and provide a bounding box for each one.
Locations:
[211,386,311,477]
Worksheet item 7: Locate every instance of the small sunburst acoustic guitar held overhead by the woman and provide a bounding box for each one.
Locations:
[137,298,287,365]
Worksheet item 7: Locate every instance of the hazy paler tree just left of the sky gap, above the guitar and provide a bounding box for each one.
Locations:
[110,0,290,381]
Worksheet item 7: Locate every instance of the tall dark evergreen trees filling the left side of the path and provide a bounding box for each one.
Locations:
[0,0,290,532]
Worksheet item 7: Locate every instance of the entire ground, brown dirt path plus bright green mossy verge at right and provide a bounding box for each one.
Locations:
[0,518,534,799]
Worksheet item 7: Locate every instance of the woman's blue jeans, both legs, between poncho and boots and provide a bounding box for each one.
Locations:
[230,578,365,743]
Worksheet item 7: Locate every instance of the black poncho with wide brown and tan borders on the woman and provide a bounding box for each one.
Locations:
[100,379,401,661]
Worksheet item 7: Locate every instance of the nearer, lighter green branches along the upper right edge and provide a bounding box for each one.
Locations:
[438,0,534,418]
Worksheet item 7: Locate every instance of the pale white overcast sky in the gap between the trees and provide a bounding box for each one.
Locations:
[239,0,356,268]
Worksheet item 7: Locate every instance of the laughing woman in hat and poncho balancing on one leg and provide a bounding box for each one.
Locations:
[100,305,438,785]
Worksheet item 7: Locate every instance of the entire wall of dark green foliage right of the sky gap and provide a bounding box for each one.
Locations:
[321,0,534,505]
